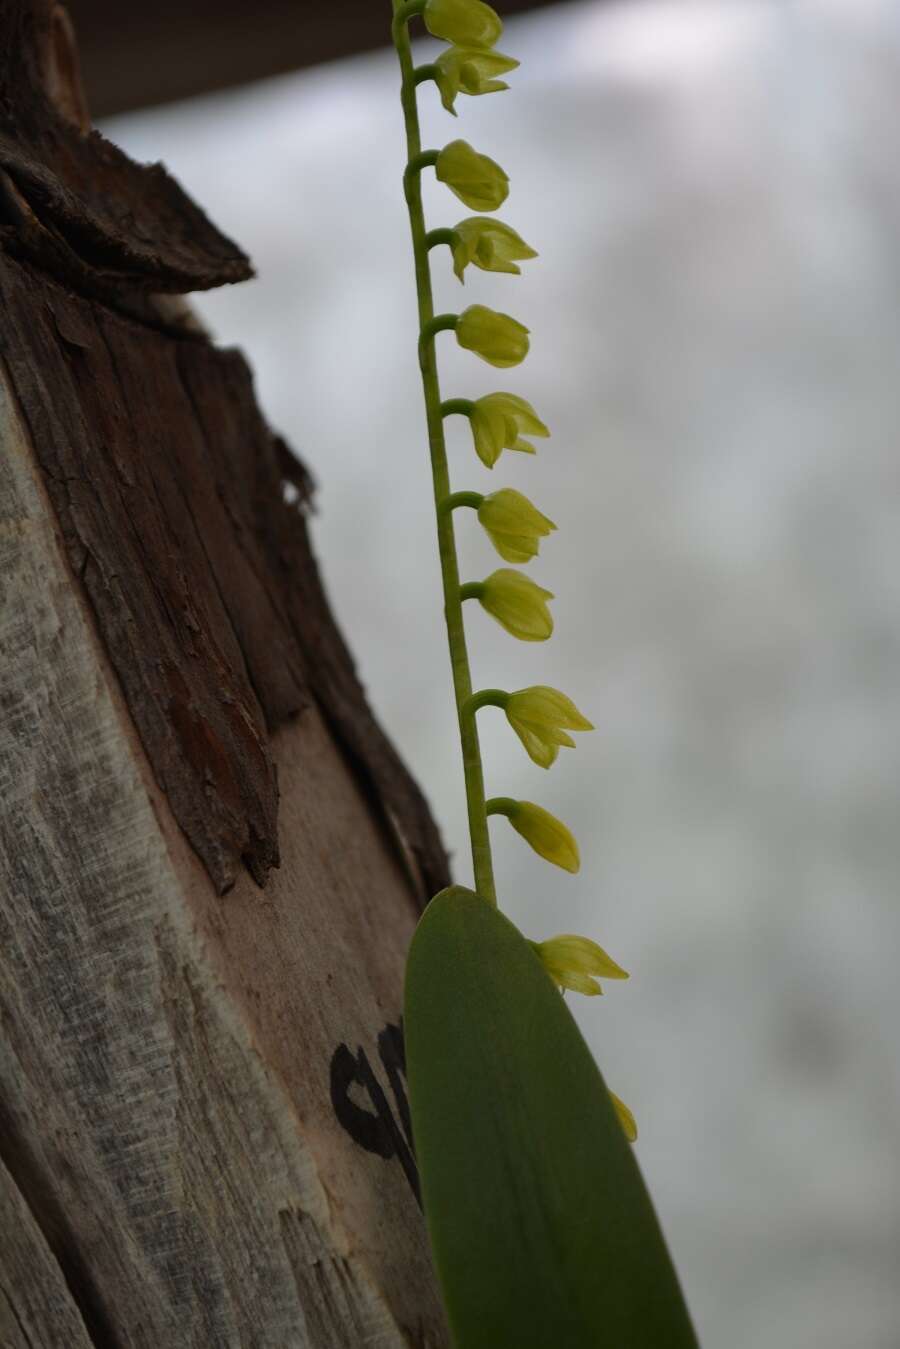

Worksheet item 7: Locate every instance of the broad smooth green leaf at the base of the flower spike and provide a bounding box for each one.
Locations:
[405,886,696,1349]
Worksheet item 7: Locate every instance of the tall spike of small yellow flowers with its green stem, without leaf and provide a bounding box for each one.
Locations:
[394,0,636,1137]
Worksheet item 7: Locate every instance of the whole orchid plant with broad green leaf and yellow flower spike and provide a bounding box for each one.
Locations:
[393,0,696,1349]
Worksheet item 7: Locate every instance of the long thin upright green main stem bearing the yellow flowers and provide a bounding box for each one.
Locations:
[394,5,497,904]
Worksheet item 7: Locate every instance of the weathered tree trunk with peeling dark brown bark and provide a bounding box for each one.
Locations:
[0,0,448,1349]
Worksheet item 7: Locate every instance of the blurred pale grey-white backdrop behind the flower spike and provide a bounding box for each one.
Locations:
[104,0,900,1349]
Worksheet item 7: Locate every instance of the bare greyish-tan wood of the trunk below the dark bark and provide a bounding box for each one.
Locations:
[0,364,447,1349]
